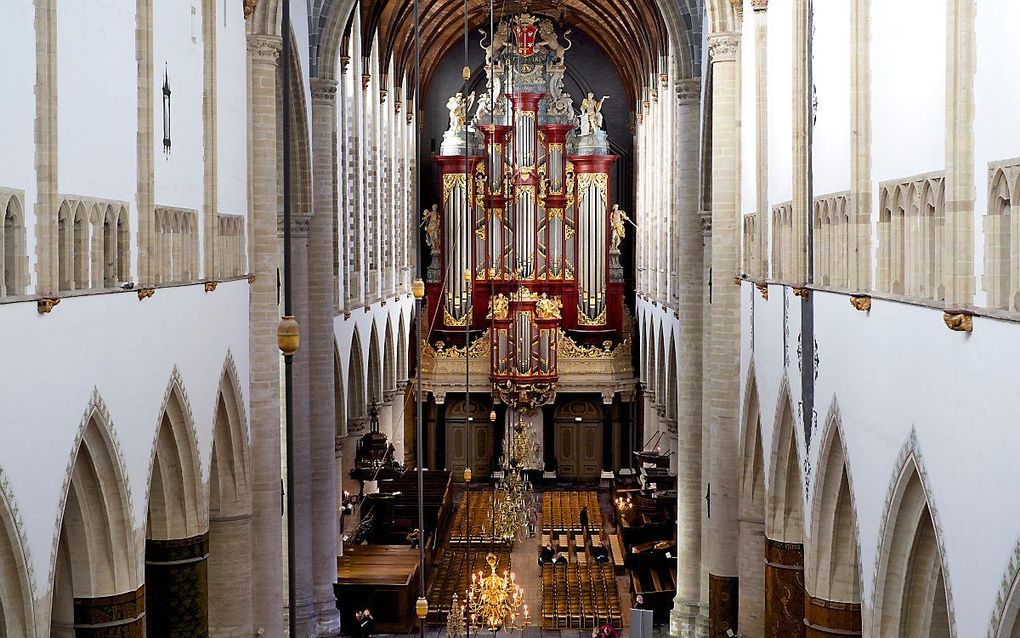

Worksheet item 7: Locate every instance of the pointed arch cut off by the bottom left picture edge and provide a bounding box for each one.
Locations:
[0,475,36,638]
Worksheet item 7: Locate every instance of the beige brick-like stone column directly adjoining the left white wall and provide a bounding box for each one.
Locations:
[242,35,284,636]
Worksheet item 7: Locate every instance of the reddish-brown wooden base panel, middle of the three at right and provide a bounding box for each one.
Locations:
[765,537,806,638]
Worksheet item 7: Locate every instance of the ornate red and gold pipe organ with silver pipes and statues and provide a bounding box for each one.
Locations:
[424,13,623,407]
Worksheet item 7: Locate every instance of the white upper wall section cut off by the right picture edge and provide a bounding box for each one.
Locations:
[974,0,1020,306]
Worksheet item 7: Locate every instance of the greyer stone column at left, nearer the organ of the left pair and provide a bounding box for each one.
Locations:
[307,79,340,636]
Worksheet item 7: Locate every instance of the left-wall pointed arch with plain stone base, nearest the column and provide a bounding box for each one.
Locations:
[208,356,253,636]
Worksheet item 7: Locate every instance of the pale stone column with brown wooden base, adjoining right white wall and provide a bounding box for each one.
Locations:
[705,33,741,638]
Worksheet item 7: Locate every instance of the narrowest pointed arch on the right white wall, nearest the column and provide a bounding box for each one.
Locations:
[737,363,765,638]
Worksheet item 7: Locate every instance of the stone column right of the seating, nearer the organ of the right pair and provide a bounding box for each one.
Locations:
[669,78,708,638]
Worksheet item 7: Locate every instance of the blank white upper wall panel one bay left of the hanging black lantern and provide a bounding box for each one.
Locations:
[57,0,136,204]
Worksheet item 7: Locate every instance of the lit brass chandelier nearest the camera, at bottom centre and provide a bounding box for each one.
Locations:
[466,552,529,633]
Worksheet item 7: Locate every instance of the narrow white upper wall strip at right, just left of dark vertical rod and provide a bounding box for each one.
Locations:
[767,0,794,208]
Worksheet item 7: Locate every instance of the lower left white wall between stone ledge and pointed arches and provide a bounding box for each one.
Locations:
[0,280,249,592]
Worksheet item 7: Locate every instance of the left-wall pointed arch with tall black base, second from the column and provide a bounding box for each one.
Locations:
[145,367,209,636]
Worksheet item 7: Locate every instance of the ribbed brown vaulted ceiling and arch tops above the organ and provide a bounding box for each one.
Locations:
[297,0,704,104]
